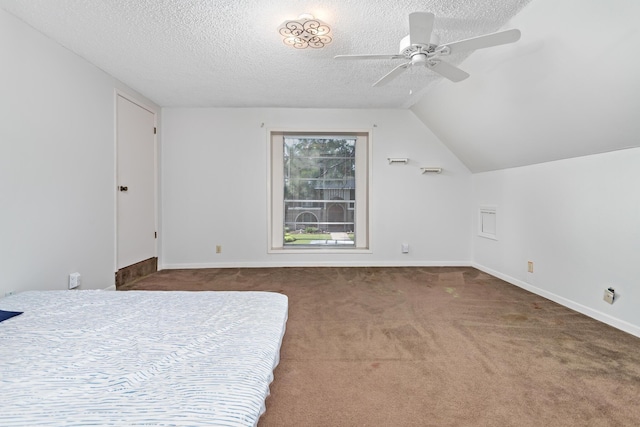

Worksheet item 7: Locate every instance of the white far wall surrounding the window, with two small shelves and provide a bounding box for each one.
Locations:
[160,108,471,268]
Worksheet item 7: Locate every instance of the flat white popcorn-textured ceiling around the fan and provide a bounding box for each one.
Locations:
[0,0,530,108]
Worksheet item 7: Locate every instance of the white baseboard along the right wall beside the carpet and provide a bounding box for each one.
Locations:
[471,262,640,338]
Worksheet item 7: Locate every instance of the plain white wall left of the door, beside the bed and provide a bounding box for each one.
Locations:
[0,10,158,297]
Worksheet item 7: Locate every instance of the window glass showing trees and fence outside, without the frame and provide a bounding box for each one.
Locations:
[283,136,356,248]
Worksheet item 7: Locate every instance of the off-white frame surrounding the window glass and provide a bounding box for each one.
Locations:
[267,130,371,254]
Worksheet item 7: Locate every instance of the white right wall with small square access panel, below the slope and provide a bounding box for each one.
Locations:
[473,148,640,336]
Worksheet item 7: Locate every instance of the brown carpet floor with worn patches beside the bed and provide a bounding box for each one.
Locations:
[119,267,640,427]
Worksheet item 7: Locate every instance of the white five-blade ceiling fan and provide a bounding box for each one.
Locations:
[334,12,520,87]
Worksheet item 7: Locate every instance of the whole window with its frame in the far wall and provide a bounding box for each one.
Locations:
[269,132,369,251]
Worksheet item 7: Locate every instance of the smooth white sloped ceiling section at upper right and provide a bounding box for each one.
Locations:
[412,0,640,172]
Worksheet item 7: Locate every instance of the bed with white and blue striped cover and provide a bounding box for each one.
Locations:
[0,290,288,427]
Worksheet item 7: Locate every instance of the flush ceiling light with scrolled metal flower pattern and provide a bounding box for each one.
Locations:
[278,13,332,49]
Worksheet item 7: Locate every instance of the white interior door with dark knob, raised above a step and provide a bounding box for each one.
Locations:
[116,95,156,270]
